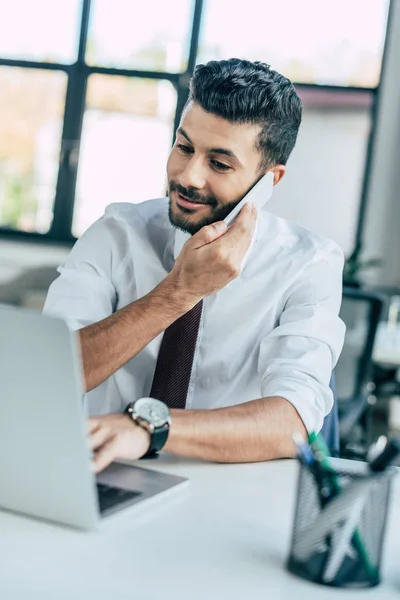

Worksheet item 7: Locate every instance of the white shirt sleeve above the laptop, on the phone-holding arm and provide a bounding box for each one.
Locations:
[43,213,131,330]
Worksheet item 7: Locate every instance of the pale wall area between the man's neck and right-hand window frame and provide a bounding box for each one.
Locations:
[269,106,370,254]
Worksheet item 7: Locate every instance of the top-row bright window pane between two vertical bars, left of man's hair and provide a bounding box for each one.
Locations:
[86,0,192,72]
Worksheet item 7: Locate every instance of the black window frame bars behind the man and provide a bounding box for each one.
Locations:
[0,0,392,247]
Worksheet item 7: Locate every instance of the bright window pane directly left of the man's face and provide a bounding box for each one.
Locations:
[73,75,176,236]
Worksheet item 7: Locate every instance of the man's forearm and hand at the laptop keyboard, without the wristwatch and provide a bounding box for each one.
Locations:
[89,397,306,473]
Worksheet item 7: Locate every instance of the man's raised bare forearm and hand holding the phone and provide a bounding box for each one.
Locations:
[79,205,256,391]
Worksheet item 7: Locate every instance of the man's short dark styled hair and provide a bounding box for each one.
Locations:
[188,58,302,170]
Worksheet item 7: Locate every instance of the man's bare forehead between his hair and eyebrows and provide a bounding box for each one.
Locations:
[180,103,260,159]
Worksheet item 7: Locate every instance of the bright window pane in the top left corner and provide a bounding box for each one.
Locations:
[0,0,81,63]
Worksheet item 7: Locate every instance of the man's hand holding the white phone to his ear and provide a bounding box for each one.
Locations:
[167,204,257,306]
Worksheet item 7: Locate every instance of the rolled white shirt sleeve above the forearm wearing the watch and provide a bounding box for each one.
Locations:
[259,242,345,432]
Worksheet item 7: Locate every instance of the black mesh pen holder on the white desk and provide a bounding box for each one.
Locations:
[287,465,394,588]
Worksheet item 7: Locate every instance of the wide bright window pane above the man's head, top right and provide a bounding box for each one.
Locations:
[197,0,389,87]
